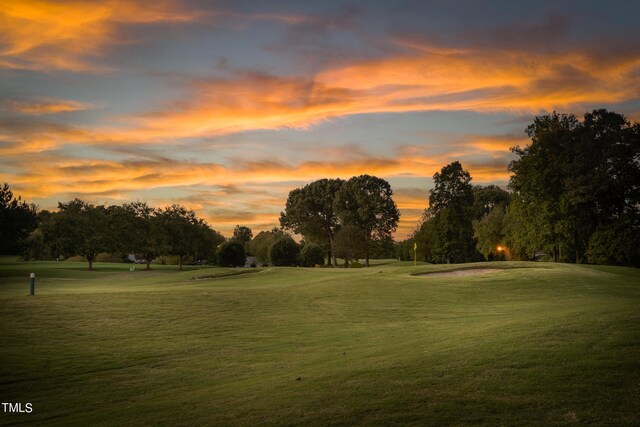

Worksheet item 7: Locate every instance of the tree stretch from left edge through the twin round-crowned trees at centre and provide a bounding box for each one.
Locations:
[0,175,399,270]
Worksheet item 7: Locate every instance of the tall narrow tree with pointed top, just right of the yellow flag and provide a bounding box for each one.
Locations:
[424,161,478,263]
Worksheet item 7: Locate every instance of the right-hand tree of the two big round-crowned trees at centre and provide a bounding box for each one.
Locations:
[334,175,400,267]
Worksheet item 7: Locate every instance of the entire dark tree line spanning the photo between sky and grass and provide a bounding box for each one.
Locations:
[0,109,640,268]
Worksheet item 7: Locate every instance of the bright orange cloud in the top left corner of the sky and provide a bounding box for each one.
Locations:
[0,0,197,72]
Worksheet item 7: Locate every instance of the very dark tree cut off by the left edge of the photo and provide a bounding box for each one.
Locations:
[0,183,37,255]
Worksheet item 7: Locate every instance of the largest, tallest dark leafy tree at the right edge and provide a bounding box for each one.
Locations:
[509,109,640,262]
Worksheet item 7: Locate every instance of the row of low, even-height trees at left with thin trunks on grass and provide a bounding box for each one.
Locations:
[5,198,225,270]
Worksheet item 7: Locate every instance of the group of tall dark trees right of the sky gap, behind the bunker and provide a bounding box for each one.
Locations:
[398,109,640,267]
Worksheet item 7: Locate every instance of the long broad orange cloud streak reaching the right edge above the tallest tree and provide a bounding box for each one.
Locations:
[121,45,640,139]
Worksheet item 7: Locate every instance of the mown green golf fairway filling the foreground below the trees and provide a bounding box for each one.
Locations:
[0,261,640,426]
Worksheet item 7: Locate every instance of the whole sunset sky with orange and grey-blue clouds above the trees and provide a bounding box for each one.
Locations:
[0,0,640,238]
